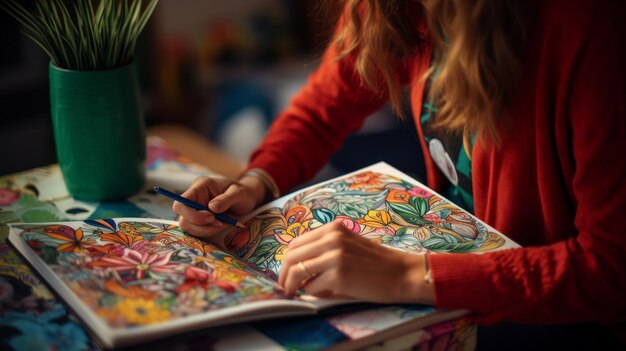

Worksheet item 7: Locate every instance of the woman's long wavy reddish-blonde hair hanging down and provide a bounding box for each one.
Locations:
[333,0,524,142]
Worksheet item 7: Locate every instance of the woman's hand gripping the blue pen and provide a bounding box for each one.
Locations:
[172,177,266,237]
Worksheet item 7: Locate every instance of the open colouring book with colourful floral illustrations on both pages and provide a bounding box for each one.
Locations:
[9,163,518,347]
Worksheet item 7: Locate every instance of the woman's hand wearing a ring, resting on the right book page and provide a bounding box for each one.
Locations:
[278,222,434,303]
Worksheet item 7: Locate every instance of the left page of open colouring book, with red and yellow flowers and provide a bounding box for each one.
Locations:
[10,218,297,336]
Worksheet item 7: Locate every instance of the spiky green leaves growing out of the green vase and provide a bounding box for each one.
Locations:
[0,0,158,71]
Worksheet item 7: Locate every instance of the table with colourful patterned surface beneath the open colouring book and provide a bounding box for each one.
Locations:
[0,126,476,350]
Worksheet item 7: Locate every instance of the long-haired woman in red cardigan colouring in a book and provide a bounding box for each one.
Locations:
[174,0,626,346]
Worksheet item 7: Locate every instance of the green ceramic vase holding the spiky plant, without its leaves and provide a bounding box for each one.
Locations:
[49,64,146,201]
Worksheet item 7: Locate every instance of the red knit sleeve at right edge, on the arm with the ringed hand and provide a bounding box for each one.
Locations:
[429,1,626,323]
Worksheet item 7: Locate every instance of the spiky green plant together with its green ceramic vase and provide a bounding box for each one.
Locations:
[0,0,158,201]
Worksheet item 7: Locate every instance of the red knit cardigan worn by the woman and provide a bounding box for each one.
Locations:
[249,0,626,323]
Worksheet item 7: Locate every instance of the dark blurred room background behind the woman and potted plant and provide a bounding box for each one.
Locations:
[0,0,423,190]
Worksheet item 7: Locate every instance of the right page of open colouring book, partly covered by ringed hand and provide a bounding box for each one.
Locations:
[220,162,518,284]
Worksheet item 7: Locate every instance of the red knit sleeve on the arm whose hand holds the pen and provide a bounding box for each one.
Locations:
[248,14,386,193]
